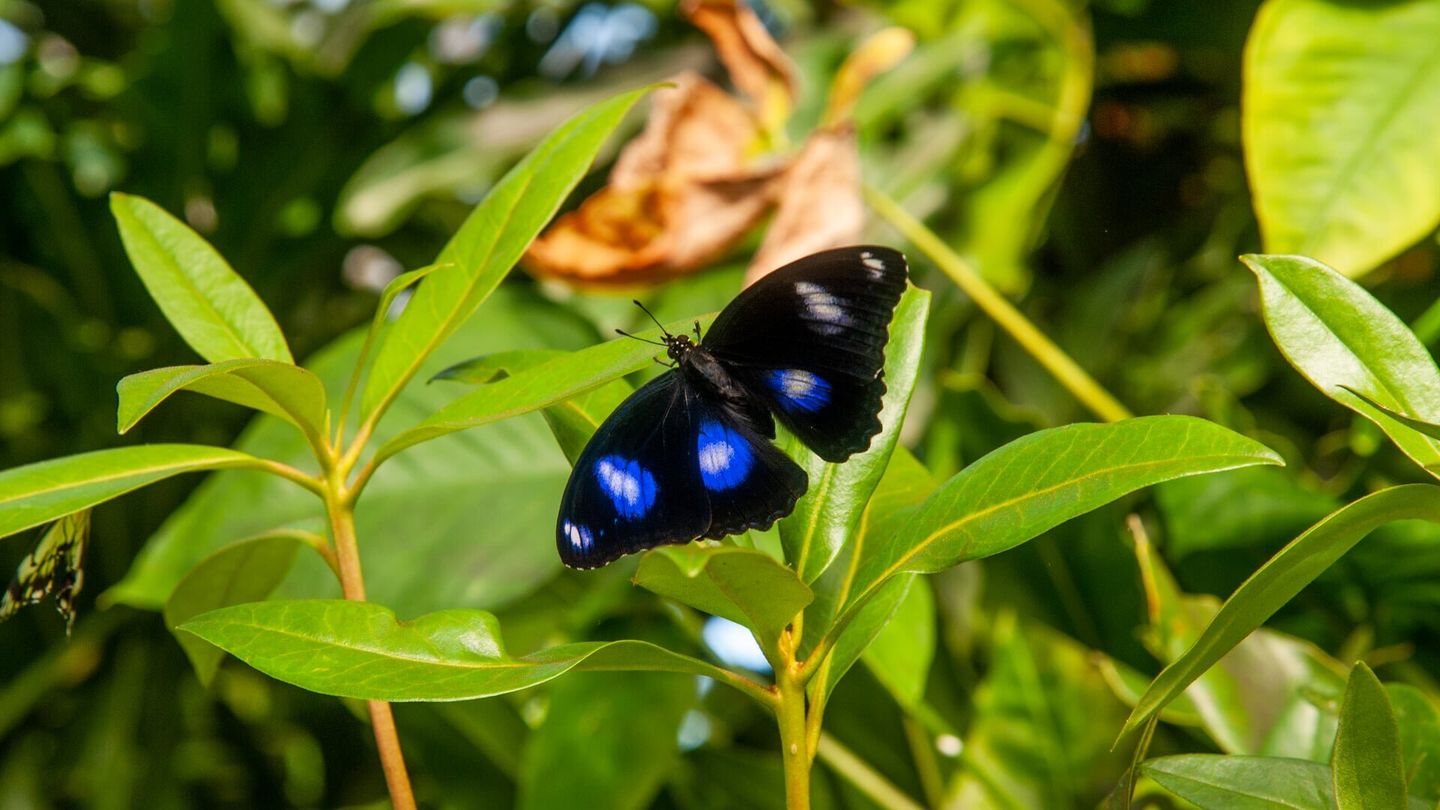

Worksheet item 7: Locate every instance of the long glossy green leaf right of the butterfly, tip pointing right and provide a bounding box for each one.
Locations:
[854,417,1280,616]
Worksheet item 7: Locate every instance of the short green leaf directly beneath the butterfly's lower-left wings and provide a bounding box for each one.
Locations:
[635,543,814,654]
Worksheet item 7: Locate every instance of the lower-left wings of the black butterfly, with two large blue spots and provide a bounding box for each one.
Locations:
[556,372,806,568]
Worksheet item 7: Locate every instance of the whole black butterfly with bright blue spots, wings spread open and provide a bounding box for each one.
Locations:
[556,245,906,568]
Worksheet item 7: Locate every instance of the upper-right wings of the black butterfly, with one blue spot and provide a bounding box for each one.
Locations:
[703,245,906,461]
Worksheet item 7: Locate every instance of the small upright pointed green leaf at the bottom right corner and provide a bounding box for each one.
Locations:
[1331,662,1405,810]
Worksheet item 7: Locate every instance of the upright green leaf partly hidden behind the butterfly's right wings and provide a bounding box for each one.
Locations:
[780,287,930,582]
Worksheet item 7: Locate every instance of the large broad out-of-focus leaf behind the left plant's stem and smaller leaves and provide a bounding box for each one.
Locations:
[108,285,595,615]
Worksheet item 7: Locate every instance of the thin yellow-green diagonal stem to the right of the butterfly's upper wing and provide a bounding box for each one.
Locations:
[865,183,1132,422]
